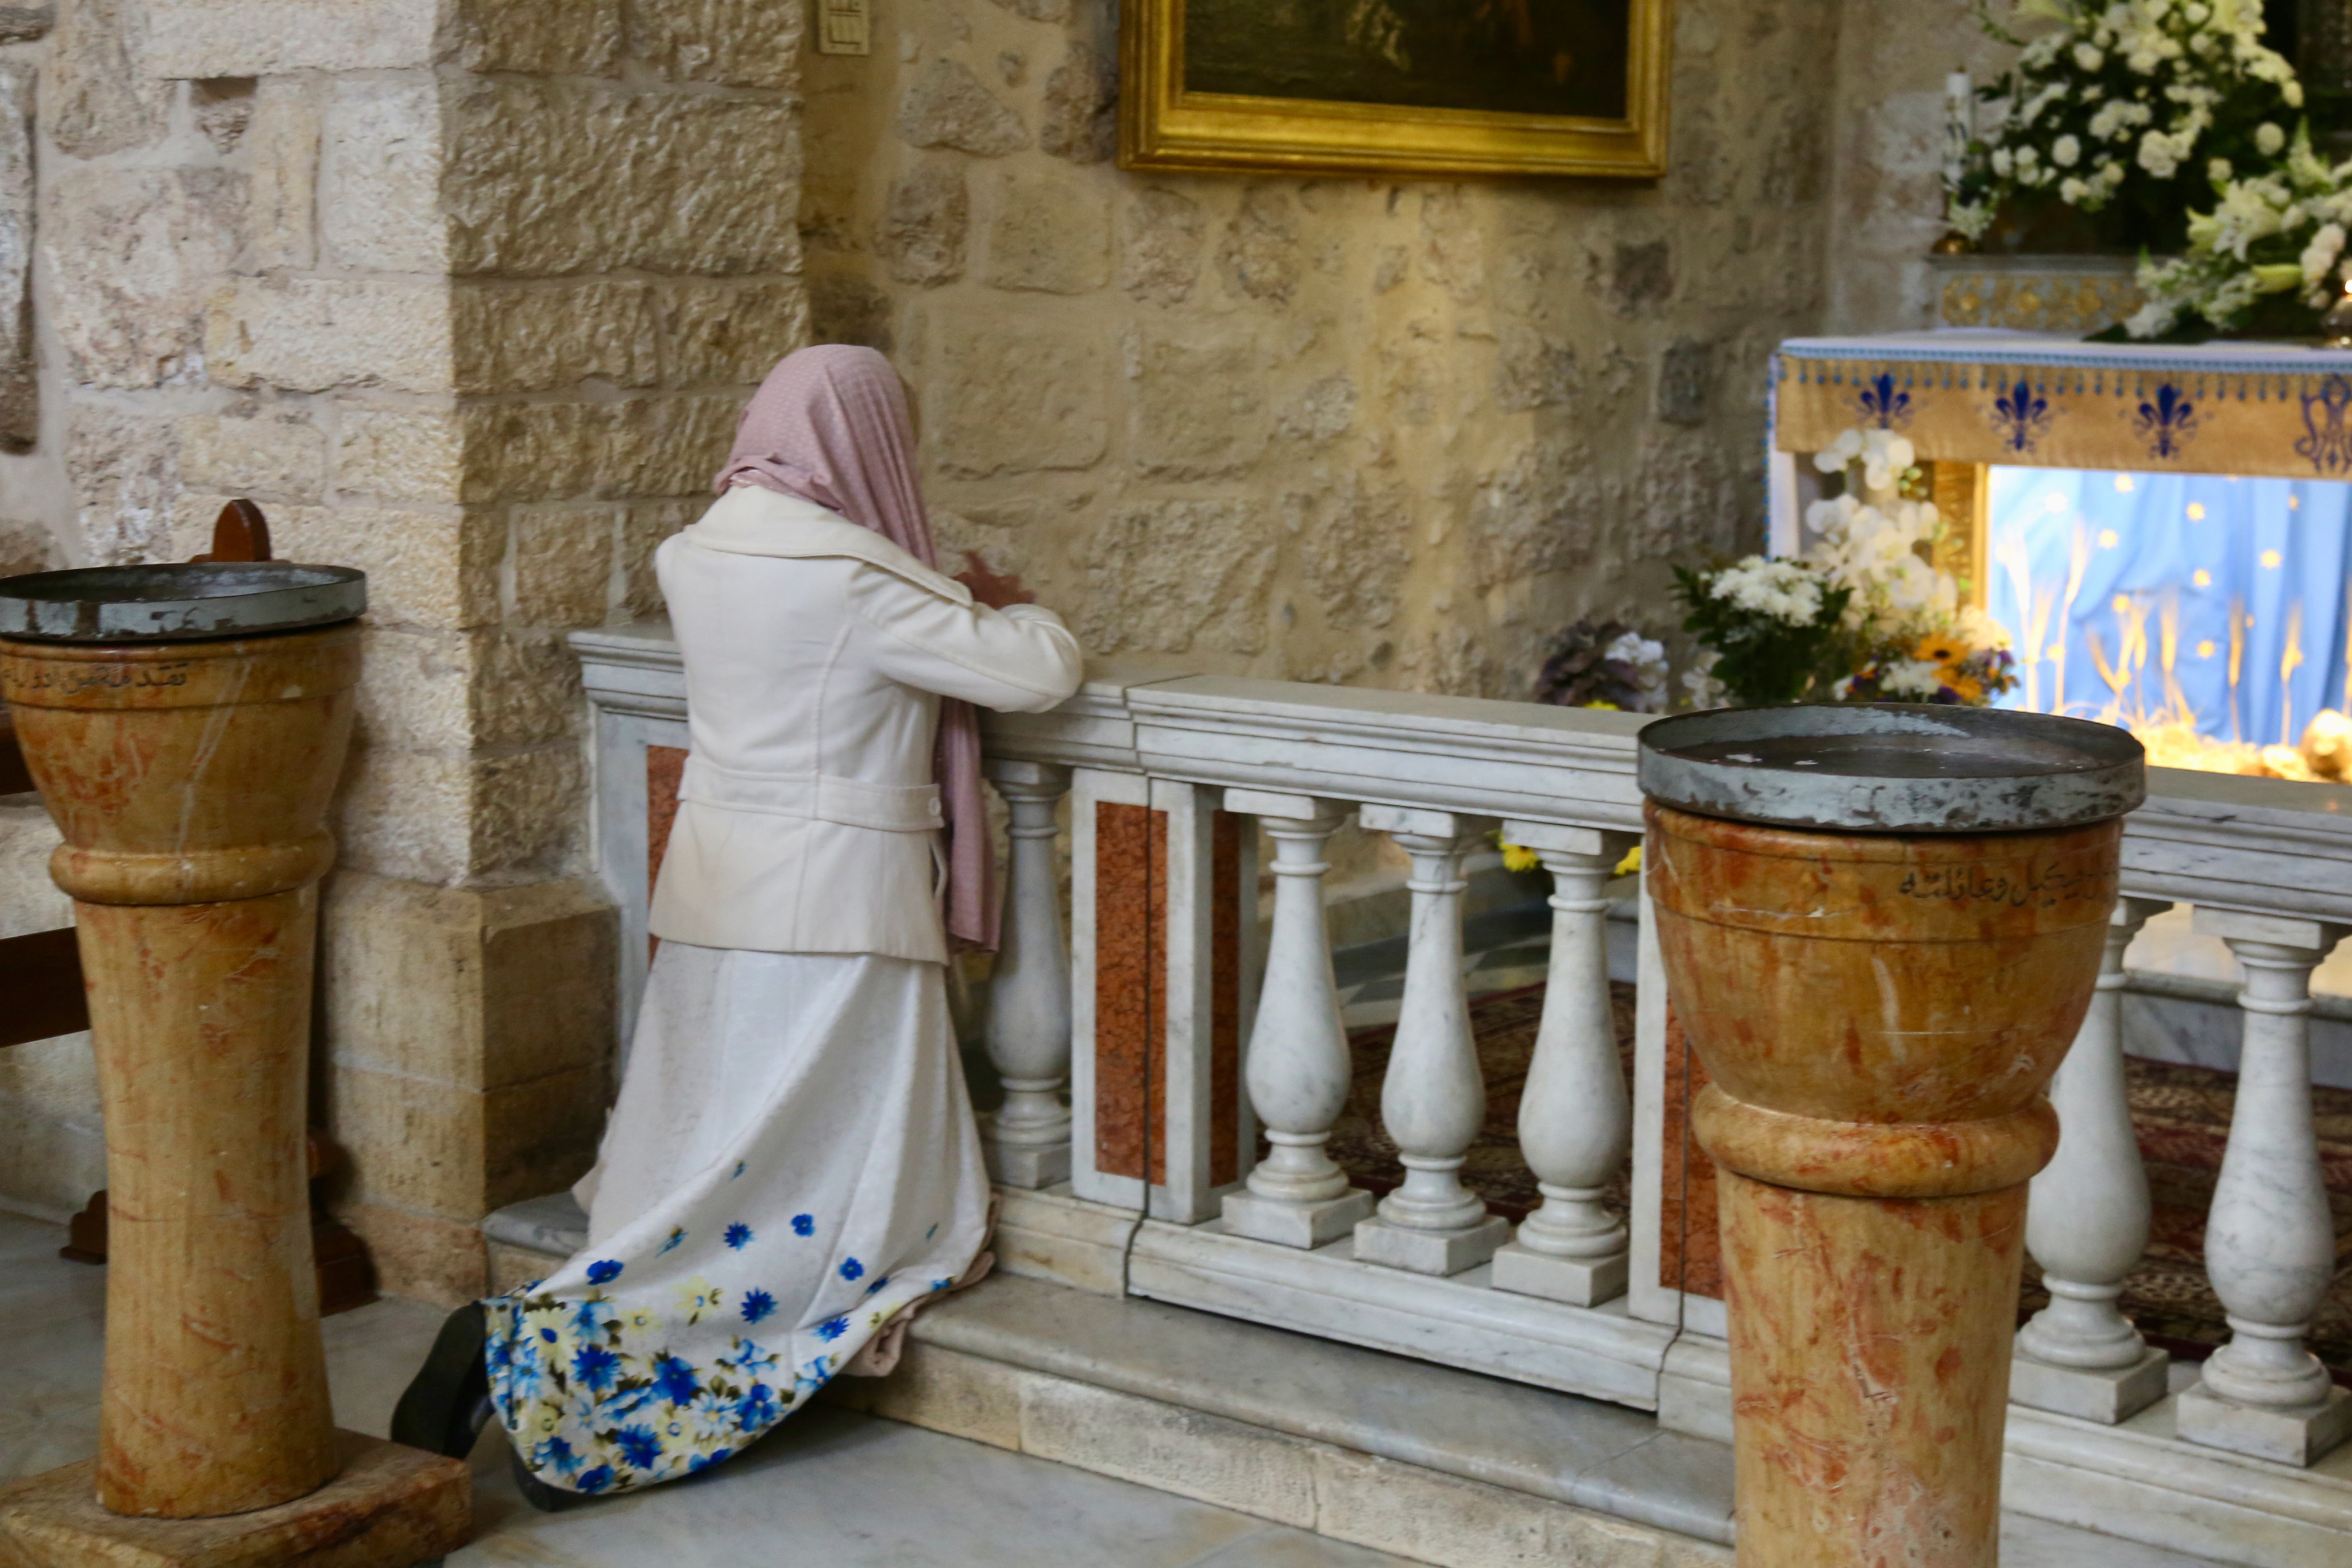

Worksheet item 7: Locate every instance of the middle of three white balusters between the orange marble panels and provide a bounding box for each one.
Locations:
[1355,806,1510,1274]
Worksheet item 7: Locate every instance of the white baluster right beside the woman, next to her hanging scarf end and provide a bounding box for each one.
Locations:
[981,762,1070,1187]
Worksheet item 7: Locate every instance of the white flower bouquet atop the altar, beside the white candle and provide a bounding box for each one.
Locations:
[1948,0,2303,252]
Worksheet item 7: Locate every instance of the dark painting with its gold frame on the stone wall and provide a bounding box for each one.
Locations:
[1119,0,1673,179]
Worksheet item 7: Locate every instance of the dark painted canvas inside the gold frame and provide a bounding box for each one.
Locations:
[1183,0,1632,120]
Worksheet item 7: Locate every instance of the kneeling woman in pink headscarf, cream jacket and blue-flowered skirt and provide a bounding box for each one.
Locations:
[393,346,1082,1507]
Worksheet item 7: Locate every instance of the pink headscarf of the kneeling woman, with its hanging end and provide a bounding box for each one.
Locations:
[713,343,997,950]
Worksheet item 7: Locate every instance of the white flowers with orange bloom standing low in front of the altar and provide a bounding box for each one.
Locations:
[1675,430,2018,708]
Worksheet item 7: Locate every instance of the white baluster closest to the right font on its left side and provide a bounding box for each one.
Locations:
[1493,823,1637,1307]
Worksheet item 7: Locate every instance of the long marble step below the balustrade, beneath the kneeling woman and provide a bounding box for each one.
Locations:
[482,1175,2213,1568]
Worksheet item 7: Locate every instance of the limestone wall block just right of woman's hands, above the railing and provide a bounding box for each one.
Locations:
[1080,499,1277,654]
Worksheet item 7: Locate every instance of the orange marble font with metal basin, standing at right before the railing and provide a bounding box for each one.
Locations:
[1642,708,2138,1568]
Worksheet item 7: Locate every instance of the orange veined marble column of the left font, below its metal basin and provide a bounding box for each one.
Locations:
[0,625,360,1519]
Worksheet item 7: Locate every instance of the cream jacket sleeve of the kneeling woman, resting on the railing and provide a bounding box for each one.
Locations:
[849,564,1087,712]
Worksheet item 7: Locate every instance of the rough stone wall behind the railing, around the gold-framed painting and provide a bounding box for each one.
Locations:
[804,0,1837,696]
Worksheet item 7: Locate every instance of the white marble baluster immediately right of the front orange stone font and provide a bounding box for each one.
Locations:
[2009,898,2171,1427]
